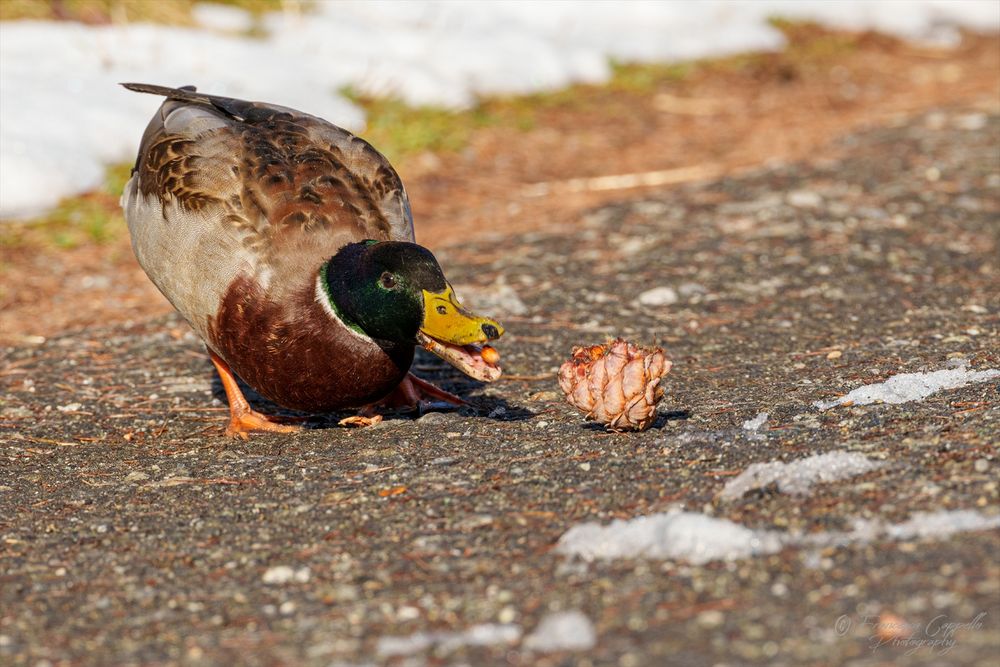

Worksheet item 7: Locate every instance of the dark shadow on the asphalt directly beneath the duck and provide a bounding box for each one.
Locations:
[206,350,535,429]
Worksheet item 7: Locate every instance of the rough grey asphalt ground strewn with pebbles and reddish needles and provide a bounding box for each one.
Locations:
[0,111,1000,667]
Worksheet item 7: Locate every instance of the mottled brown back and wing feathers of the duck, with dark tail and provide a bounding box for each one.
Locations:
[128,86,413,254]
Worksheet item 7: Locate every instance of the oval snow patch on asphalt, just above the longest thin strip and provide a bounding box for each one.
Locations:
[719,452,882,500]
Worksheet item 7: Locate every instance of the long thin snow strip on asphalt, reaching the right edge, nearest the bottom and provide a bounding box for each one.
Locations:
[556,510,1000,565]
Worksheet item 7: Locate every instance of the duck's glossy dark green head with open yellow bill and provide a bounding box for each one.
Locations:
[321,240,503,382]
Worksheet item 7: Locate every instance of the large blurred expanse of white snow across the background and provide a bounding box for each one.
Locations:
[0,0,1000,217]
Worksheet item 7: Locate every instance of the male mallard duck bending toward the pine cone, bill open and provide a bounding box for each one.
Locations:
[122,83,503,438]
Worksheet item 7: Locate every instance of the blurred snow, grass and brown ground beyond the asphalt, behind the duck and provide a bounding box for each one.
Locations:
[0,0,1000,345]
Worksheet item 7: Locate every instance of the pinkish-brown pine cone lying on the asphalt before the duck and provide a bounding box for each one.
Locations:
[559,338,672,431]
